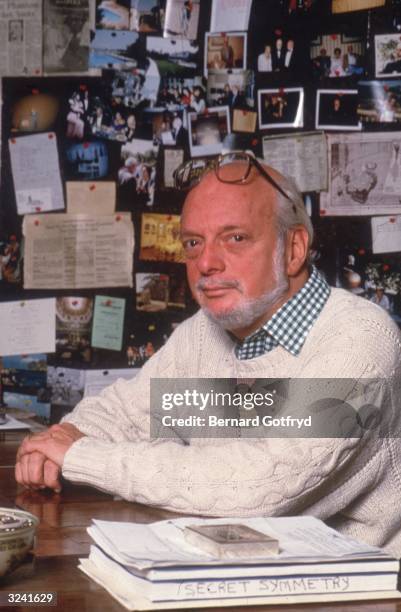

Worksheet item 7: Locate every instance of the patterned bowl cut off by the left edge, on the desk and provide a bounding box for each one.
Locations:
[0,508,39,577]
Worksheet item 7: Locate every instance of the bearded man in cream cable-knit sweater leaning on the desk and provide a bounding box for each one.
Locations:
[16,153,401,554]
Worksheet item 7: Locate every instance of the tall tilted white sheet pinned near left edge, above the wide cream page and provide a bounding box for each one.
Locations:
[8,132,64,215]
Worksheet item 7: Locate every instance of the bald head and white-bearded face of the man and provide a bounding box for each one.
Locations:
[181,162,308,337]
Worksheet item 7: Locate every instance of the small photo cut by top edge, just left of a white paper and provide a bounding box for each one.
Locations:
[163,0,200,40]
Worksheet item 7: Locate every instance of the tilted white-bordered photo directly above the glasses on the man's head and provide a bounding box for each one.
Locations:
[188,106,231,157]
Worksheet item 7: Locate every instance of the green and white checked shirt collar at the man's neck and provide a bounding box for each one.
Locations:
[235,266,330,359]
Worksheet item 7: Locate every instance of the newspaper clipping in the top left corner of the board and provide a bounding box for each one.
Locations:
[0,0,42,76]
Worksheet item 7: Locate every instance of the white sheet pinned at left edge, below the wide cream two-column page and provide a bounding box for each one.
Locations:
[0,298,56,355]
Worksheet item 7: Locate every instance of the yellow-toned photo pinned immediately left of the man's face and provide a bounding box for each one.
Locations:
[139,213,185,263]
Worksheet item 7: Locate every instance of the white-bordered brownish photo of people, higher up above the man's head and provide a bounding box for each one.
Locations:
[205,32,247,76]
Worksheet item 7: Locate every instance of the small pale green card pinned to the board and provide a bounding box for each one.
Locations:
[92,295,125,351]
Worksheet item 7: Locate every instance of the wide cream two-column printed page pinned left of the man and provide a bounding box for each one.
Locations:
[23,213,134,290]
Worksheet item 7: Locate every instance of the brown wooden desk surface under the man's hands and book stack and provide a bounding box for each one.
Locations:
[0,435,401,612]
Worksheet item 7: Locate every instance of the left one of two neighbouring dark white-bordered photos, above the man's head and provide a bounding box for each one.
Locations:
[258,87,304,130]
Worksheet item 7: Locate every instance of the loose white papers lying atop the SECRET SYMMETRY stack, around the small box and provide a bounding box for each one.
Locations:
[88,516,384,569]
